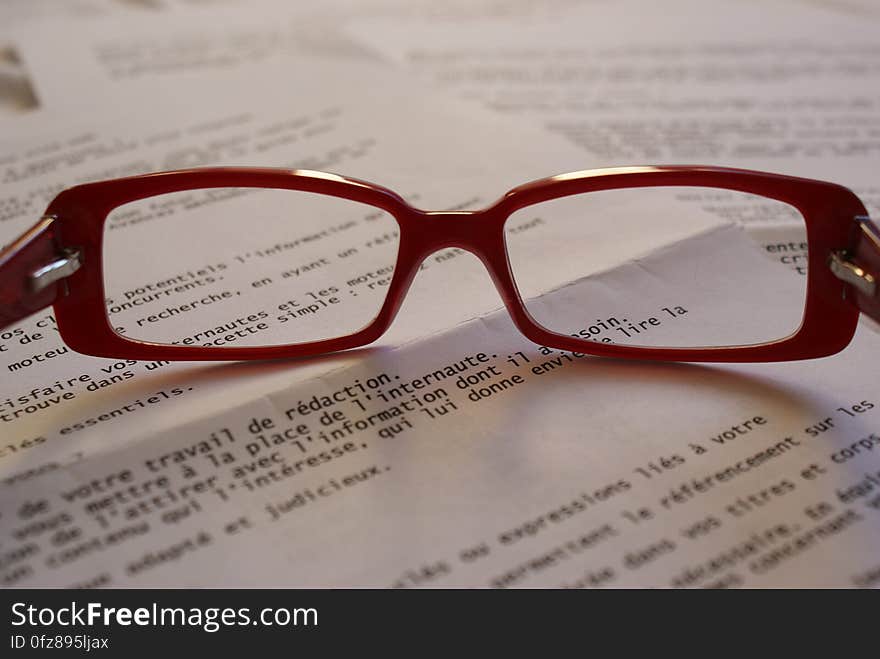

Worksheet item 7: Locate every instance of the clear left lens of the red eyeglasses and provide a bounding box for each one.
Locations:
[104,188,399,347]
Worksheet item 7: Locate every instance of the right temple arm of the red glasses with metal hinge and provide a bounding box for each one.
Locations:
[829,216,880,322]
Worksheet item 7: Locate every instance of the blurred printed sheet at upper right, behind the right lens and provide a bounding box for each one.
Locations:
[346,0,880,217]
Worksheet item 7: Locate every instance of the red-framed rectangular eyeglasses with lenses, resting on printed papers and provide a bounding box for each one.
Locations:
[0,166,880,362]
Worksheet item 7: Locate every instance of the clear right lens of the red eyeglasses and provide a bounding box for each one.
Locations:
[505,187,807,348]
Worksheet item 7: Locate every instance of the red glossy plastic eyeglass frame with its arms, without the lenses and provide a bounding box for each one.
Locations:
[0,166,880,362]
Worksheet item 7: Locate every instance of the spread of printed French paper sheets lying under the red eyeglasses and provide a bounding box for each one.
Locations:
[0,0,880,588]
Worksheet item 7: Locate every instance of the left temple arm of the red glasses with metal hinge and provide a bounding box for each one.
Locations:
[0,216,81,329]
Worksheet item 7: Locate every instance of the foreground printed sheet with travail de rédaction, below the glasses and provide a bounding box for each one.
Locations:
[0,232,880,588]
